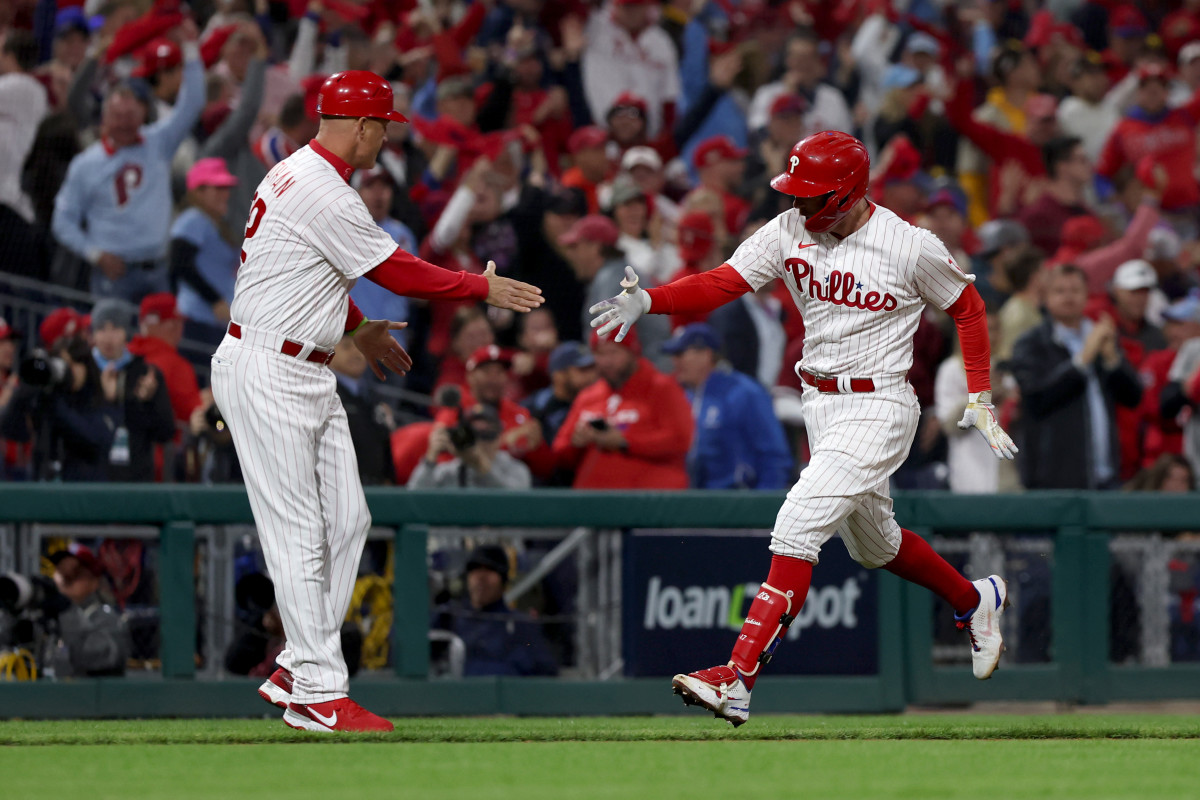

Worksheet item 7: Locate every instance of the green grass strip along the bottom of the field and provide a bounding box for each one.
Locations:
[0,715,1200,800]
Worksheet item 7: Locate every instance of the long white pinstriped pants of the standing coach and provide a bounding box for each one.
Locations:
[212,336,371,703]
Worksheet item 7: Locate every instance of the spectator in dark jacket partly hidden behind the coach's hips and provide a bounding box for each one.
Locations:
[329,336,396,486]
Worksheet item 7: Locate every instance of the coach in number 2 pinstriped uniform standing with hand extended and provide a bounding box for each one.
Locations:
[212,71,542,730]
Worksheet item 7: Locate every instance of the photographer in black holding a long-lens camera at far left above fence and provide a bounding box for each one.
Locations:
[0,326,113,481]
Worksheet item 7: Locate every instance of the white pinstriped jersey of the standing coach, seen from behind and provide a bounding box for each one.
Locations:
[230,145,396,350]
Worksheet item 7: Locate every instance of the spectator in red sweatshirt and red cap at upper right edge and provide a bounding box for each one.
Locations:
[1096,64,1200,212]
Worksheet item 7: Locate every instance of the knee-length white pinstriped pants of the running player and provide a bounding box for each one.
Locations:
[770,384,920,569]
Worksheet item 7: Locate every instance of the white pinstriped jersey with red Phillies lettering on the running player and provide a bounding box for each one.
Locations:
[727,205,974,378]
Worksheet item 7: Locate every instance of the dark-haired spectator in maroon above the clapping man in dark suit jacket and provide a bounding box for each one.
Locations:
[1016,137,1094,253]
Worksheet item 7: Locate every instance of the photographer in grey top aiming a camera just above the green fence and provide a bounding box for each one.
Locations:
[408,405,530,489]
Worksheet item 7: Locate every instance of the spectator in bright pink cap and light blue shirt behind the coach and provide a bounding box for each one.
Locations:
[169,158,237,327]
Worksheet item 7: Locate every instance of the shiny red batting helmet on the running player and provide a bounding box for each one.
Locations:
[770,131,871,234]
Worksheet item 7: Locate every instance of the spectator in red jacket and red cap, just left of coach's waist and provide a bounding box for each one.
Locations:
[130,291,200,425]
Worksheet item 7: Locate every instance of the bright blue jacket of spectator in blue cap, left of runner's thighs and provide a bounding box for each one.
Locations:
[686,365,792,489]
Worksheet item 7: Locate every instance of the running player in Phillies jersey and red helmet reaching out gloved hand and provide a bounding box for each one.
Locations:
[592,131,1016,726]
